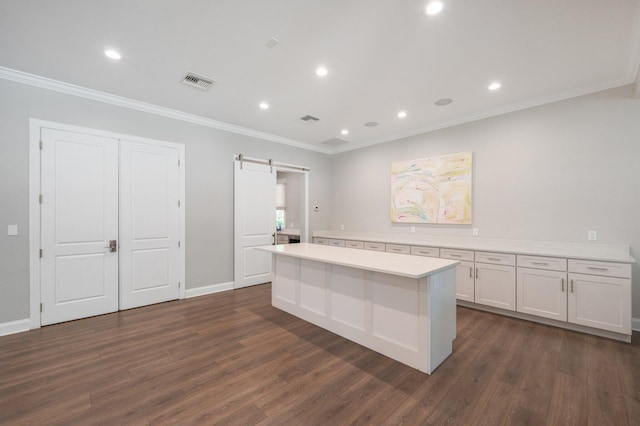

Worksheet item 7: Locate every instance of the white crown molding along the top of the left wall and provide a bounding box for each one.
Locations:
[0,67,331,154]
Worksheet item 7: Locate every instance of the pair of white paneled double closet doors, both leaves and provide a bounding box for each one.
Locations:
[40,128,184,325]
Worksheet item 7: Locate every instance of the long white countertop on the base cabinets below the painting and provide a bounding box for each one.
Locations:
[313,231,636,263]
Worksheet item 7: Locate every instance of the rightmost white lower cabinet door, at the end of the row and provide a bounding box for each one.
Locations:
[568,274,631,335]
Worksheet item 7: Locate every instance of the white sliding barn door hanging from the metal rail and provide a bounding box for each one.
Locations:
[234,161,276,288]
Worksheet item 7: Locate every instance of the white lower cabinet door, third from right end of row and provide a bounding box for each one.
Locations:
[475,263,516,311]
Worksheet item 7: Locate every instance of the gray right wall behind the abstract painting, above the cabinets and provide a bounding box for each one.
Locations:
[331,86,640,318]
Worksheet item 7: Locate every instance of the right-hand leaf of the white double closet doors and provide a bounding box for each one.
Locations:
[120,140,182,309]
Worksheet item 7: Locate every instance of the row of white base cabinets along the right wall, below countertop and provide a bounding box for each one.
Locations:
[314,237,631,341]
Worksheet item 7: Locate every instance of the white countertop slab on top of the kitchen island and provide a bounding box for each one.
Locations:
[256,243,459,279]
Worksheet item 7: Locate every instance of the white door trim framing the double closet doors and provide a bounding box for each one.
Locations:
[29,118,186,329]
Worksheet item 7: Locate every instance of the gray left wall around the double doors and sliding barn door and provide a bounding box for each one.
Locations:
[0,79,331,323]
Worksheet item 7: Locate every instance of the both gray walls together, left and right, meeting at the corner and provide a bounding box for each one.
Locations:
[0,76,640,323]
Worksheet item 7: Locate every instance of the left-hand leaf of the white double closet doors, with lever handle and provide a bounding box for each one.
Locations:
[40,129,118,325]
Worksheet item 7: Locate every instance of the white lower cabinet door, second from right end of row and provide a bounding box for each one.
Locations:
[516,268,567,321]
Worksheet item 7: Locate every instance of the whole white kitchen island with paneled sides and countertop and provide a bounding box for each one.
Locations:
[258,243,459,374]
